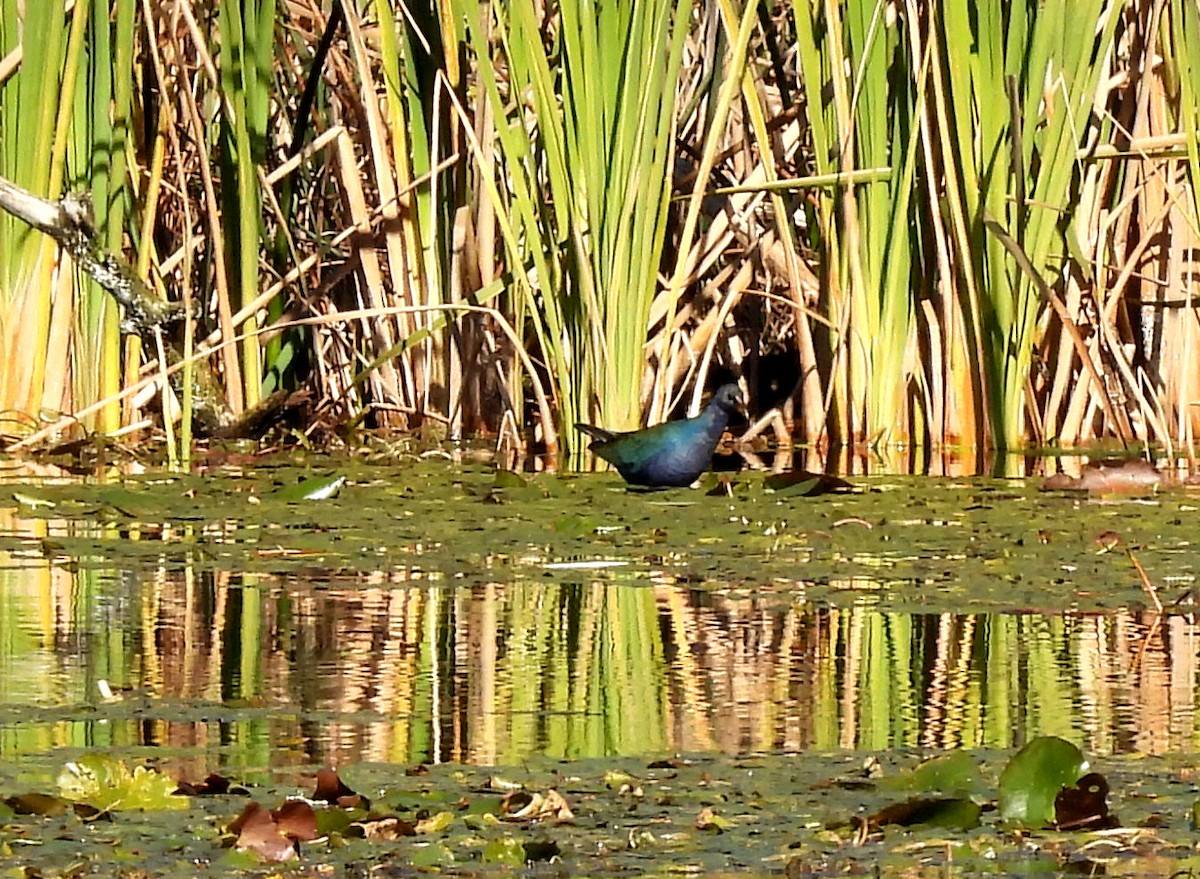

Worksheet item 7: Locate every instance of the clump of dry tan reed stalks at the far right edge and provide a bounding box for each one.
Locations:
[1022,4,1200,450]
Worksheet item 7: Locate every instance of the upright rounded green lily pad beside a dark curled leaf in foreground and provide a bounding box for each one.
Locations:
[1000,736,1087,827]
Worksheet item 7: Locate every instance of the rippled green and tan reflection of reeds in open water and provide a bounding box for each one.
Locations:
[0,545,1200,766]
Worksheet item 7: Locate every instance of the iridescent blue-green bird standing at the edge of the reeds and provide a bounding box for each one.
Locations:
[575,384,742,489]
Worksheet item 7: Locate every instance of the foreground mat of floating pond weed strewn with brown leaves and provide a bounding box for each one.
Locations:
[0,737,1195,878]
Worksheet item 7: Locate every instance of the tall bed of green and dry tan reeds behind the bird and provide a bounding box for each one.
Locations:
[0,0,1200,465]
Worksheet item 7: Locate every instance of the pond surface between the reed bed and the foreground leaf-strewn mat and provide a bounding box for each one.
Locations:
[0,460,1200,771]
